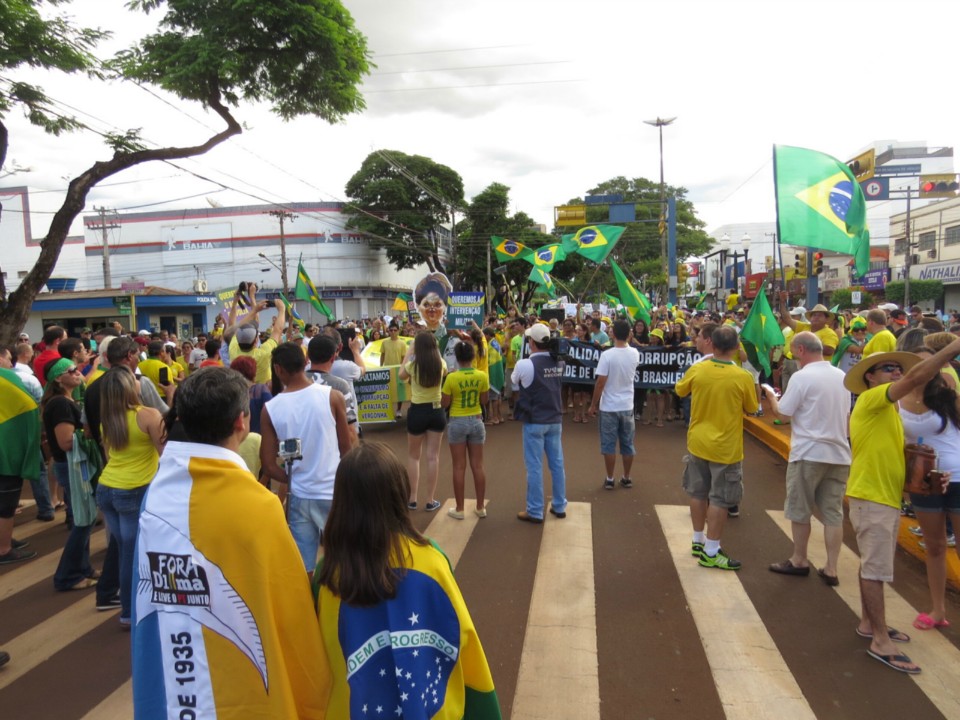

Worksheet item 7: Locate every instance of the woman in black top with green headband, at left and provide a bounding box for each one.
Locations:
[40,358,99,590]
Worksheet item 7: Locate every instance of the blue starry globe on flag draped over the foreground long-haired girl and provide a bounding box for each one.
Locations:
[339,570,460,720]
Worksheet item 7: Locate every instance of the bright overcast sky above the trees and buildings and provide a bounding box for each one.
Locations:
[0,0,960,242]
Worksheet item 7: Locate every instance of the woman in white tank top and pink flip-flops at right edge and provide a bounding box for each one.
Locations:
[900,348,960,630]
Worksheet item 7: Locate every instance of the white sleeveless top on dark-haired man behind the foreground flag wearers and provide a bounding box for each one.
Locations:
[264,383,340,500]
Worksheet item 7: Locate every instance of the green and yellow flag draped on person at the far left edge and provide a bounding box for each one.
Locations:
[0,368,40,480]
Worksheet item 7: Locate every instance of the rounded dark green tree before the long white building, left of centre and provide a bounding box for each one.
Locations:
[344,150,463,272]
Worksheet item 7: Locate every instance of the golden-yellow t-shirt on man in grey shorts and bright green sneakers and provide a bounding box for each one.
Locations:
[674,359,759,465]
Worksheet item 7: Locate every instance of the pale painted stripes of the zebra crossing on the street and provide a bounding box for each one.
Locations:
[0,500,960,720]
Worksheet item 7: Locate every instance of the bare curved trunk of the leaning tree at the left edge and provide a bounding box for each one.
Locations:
[0,91,242,344]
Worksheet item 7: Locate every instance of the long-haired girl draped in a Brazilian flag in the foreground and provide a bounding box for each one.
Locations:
[314,443,500,718]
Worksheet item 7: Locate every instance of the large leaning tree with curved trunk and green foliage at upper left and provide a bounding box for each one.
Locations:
[0,0,370,342]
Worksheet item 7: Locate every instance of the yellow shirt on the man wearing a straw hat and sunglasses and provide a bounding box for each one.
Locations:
[847,383,907,508]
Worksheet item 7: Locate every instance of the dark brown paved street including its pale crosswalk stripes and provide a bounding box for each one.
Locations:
[0,420,960,720]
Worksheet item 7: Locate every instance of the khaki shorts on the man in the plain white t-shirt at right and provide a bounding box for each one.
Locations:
[783,460,850,527]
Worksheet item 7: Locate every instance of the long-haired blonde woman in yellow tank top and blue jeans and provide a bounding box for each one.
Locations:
[97,368,164,628]
